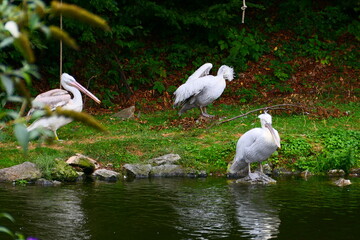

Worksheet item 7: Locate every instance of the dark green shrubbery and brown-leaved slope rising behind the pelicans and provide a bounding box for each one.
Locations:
[0,0,360,106]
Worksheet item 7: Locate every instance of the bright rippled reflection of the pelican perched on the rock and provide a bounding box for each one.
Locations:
[229,184,281,240]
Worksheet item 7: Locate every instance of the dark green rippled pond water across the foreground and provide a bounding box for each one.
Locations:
[0,177,360,240]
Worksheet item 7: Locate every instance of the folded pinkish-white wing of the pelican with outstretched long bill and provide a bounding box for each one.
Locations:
[27,89,71,116]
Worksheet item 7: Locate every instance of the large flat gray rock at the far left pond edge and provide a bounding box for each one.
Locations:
[0,162,42,182]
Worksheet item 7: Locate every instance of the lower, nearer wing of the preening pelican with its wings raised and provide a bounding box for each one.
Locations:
[174,76,214,107]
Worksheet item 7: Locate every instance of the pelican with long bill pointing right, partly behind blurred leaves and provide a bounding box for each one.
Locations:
[27,73,100,140]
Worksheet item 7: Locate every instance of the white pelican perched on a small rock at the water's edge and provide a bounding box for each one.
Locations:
[229,113,280,178]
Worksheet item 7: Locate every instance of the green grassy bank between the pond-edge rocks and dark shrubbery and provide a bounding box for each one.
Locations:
[0,103,360,174]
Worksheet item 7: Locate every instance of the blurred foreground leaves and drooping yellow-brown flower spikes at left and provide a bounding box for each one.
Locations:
[0,0,110,152]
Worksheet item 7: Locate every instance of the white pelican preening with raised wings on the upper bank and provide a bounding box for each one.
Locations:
[174,63,234,117]
